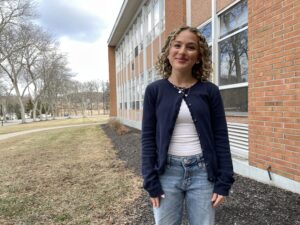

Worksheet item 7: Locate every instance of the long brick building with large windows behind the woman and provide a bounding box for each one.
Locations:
[108,0,300,193]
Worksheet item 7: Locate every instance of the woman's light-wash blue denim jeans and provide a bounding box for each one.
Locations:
[153,155,215,225]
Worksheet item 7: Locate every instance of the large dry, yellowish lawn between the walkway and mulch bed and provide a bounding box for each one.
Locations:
[0,125,142,225]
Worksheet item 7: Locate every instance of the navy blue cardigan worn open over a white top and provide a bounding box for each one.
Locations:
[142,79,234,197]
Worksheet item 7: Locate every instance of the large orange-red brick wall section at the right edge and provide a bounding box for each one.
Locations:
[248,0,300,181]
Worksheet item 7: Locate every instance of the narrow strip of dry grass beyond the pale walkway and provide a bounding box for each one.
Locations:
[0,115,108,134]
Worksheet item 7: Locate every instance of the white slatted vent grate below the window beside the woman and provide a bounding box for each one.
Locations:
[227,122,249,159]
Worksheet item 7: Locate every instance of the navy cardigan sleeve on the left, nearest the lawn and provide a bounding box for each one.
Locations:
[142,85,163,197]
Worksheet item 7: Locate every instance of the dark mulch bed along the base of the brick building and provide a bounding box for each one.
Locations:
[101,124,300,225]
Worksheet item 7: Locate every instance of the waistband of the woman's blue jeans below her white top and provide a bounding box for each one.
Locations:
[167,154,204,166]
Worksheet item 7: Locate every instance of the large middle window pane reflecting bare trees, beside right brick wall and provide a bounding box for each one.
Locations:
[219,30,248,85]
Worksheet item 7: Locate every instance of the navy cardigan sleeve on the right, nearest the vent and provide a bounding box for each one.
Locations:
[210,86,234,196]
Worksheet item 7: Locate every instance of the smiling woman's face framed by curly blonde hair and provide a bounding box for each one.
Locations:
[168,30,199,75]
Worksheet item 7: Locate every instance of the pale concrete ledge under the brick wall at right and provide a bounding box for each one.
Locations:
[233,158,300,194]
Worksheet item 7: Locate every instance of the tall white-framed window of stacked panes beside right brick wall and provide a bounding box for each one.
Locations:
[217,0,248,113]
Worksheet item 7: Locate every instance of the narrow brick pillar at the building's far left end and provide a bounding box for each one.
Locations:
[108,46,117,117]
